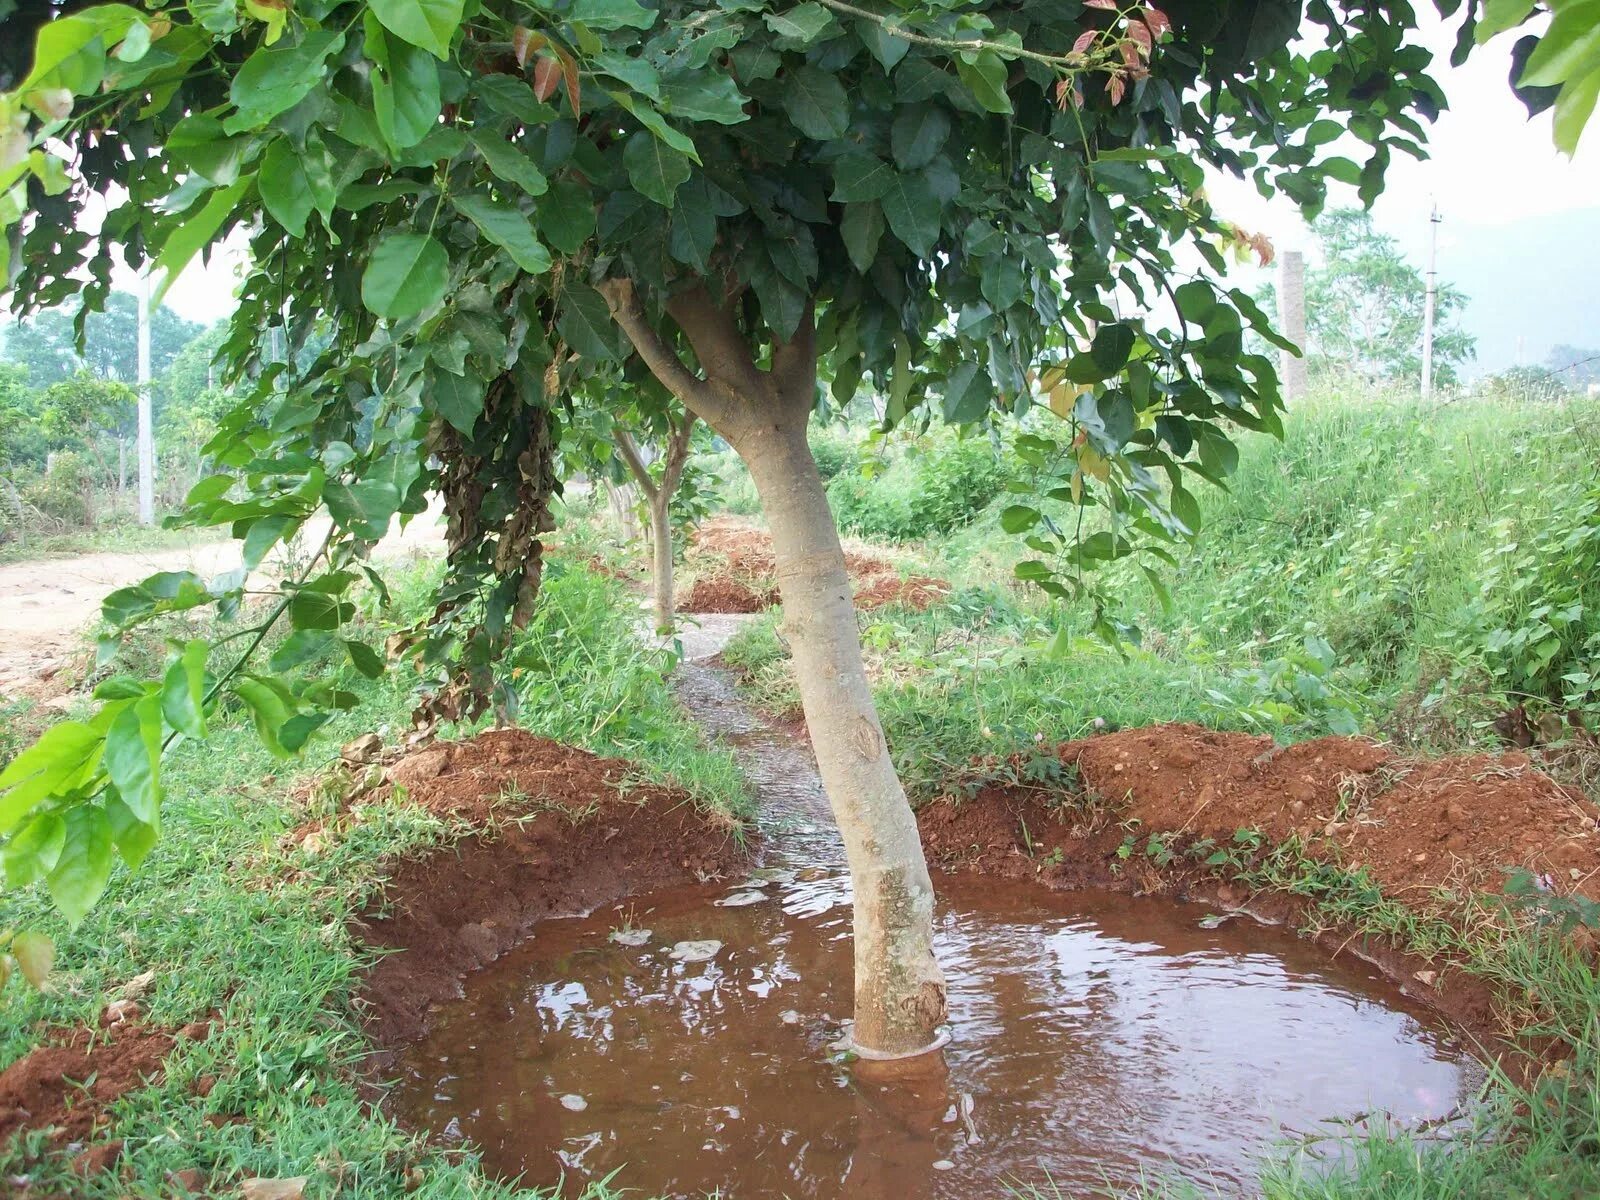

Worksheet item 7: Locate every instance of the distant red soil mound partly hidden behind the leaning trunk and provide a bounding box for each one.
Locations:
[678,517,950,613]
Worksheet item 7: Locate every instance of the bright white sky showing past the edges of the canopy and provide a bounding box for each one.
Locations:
[140,5,1600,339]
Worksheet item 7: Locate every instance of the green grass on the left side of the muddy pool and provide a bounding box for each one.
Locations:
[0,568,749,1200]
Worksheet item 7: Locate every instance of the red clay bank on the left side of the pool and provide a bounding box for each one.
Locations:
[352,730,750,1066]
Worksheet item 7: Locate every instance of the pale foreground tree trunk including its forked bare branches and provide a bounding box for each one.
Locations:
[606,280,946,1059]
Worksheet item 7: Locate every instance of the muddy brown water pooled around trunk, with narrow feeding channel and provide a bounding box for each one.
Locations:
[394,630,1482,1200]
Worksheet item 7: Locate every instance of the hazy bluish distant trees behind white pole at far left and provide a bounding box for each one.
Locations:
[5,291,202,387]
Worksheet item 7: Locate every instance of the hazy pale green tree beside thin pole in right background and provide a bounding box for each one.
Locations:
[1306,208,1474,382]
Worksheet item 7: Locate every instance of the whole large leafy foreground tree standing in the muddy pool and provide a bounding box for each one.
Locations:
[0,0,1529,1056]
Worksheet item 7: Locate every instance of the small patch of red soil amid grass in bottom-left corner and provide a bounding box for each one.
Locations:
[0,1021,210,1157]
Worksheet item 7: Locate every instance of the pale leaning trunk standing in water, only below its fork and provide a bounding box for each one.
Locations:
[734,414,946,1058]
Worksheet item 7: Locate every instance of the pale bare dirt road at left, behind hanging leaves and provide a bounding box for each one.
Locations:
[0,512,443,699]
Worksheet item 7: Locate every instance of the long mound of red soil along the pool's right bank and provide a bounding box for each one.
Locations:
[922,725,1600,902]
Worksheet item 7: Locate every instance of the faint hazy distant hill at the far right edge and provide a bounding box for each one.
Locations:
[1402,208,1600,376]
